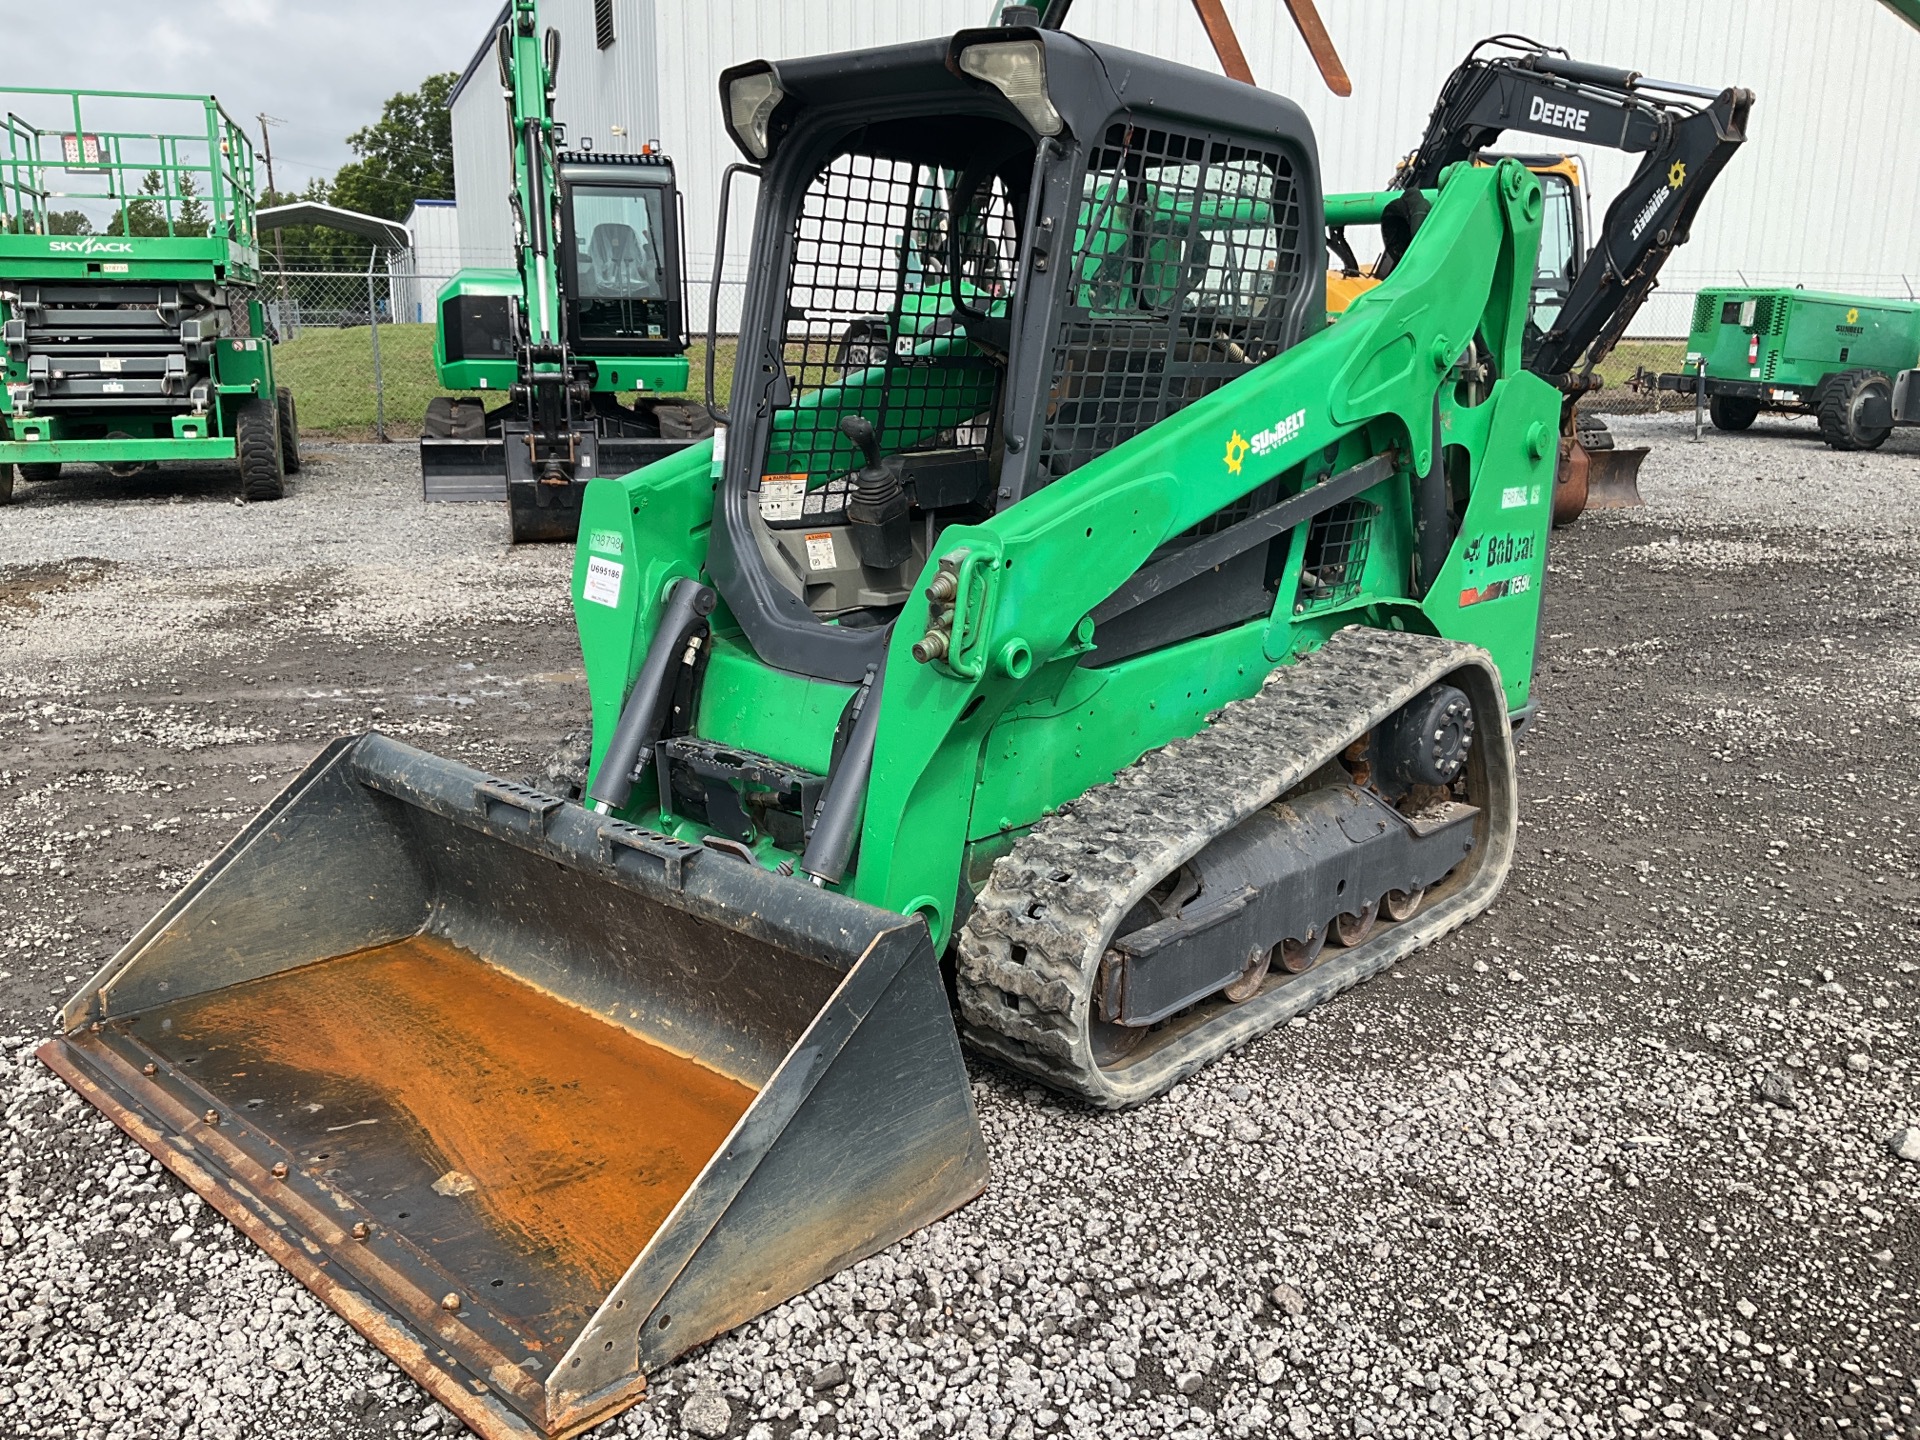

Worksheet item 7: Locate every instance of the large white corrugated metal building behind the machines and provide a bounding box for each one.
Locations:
[453,0,1920,334]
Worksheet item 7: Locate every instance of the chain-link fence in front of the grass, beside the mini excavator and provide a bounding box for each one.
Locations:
[259,259,745,440]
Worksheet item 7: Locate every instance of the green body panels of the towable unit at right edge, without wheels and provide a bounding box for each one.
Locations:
[1684,288,1920,388]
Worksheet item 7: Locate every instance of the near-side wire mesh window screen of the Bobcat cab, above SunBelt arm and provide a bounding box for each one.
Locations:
[1041,123,1308,478]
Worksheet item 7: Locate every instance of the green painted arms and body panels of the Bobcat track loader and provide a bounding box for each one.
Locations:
[574,161,1559,945]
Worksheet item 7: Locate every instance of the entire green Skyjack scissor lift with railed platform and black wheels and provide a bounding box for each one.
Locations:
[0,88,300,503]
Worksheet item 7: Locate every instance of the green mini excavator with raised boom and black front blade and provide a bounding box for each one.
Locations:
[420,0,712,541]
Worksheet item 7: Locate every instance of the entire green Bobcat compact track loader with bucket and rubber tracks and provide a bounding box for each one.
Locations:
[42,10,1561,1440]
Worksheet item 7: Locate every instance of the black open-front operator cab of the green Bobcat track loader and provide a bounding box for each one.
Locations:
[708,27,1325,682]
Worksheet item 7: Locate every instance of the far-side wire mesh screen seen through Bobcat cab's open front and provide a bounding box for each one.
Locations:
[760,126,1031,506]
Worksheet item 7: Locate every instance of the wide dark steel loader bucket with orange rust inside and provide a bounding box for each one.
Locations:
[40,735,987,1440]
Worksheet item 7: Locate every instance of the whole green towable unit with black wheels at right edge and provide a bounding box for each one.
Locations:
[1655,286,1920,449]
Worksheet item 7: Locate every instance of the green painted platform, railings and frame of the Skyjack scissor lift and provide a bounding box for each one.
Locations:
[0,86,275,465]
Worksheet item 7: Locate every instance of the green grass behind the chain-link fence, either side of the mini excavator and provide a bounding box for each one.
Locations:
[273,324,735,440]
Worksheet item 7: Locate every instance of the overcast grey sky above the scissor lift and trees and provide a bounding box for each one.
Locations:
[0,0,499,190]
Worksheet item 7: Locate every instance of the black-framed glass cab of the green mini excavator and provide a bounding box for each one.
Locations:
[559,154,685,355]
